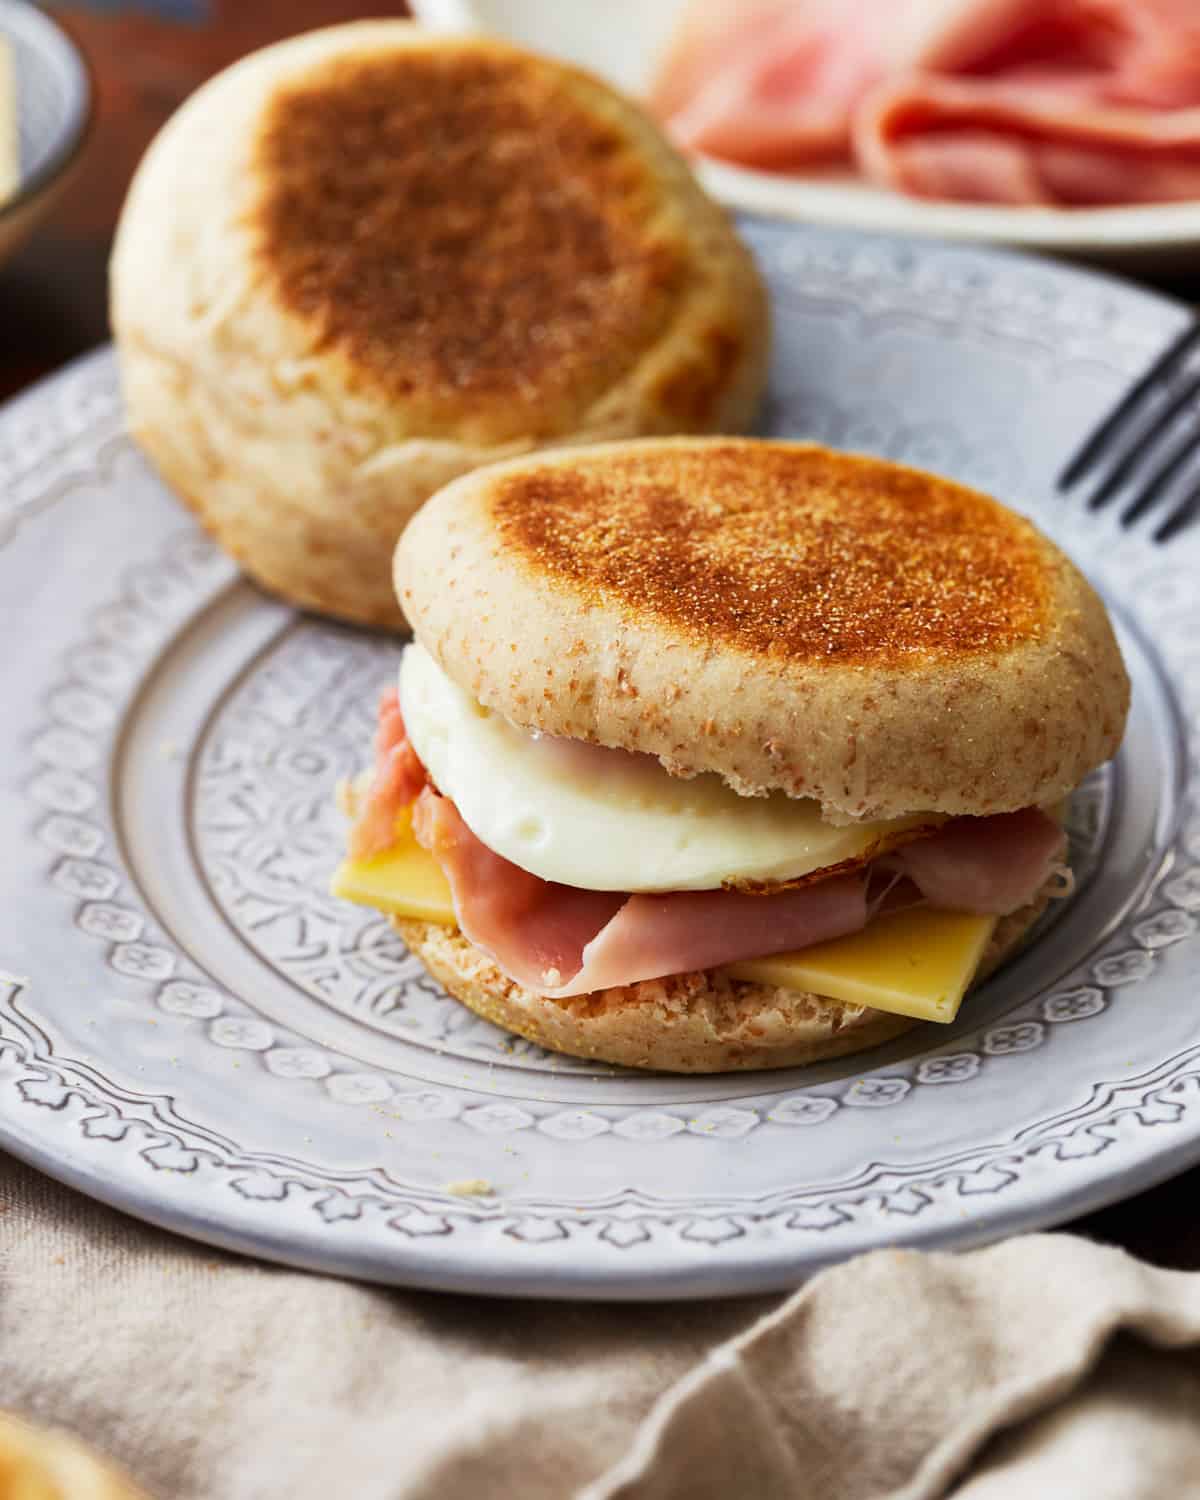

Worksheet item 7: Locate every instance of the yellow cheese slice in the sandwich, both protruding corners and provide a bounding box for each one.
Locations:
[333,813,996,1022]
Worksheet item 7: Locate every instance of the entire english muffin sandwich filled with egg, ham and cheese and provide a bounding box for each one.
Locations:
[335,438,1128,1073]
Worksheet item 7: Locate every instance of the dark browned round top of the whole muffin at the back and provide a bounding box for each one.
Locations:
[254,42,693,437]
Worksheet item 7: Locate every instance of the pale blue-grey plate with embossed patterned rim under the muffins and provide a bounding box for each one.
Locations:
[0,222,1200,1298]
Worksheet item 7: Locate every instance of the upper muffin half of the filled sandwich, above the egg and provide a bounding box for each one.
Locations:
[396,438,1130,822]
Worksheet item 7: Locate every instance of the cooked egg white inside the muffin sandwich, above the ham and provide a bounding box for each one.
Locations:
[399,645,929,891]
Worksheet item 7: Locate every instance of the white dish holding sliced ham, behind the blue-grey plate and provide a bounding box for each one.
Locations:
[410,0,1200,272]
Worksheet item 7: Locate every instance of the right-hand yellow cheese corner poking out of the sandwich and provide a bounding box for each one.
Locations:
[725,906,998,1022]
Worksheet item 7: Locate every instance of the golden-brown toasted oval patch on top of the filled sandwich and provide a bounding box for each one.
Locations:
[489,443,1050,665]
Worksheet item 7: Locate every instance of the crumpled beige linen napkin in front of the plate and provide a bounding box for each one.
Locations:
[0,1158,1200,1500]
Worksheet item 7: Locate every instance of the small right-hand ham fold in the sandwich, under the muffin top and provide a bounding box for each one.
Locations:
[887,807,1067,917]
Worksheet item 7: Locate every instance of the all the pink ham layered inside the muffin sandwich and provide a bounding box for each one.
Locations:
[351,695,1064,998]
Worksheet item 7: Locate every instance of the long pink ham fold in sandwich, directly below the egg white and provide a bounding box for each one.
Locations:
[413,786,867,999]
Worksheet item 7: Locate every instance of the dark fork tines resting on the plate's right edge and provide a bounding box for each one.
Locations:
[1058,323,1200,542]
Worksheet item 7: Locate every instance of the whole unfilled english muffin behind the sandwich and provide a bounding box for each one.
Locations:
[111,21,767,626]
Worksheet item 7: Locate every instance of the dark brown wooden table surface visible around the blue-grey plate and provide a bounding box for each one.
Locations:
[0,0,1200,1271]
